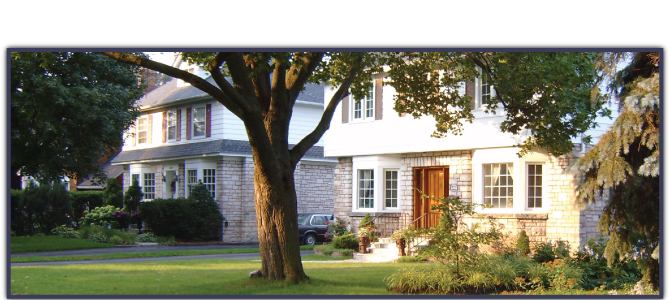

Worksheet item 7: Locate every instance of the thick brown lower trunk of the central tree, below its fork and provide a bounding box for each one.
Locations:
[254,151,309,283]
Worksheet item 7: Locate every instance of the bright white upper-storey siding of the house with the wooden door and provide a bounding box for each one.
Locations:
[324,82,616,157]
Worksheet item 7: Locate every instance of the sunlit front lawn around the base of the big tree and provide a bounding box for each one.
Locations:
[11,257,406,295]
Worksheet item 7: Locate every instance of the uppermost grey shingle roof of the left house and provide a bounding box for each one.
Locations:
[137,76,324,107]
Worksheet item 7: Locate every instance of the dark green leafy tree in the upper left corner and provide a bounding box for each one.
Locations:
[10,52,148,186]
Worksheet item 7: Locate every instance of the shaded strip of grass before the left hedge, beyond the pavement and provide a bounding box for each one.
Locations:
[10,235,114,253]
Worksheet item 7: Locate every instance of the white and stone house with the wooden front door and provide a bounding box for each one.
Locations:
[324,75,611,251]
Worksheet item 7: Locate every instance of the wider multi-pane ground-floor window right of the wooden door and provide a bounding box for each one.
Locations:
[483,163,514,208]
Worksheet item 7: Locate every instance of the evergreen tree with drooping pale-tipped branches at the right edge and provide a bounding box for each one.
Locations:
[572,53,660,289]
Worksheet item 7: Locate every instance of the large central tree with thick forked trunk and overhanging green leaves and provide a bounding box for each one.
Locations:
[103,52,600,282]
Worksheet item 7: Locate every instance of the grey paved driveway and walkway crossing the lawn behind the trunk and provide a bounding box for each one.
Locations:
[11,243,314,267]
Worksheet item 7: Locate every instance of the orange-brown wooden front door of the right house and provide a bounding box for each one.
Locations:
[414,167,449,228]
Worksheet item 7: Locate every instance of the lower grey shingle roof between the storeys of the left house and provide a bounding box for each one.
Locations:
[112,140,334,164]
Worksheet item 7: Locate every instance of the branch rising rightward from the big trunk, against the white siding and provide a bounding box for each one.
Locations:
[289,56,363,167]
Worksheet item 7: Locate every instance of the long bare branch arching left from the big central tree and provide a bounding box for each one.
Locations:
[100,52,247,118]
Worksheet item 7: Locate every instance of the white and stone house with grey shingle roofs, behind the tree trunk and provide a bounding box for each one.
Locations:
[112,60,337,243]
